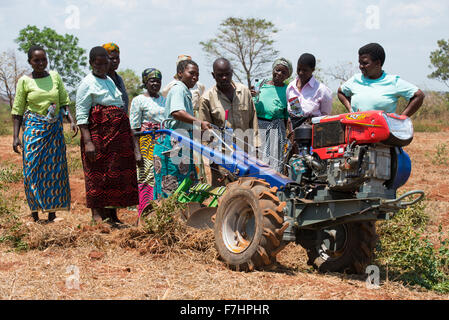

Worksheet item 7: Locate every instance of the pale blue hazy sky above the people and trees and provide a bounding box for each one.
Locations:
[0,0,449,92]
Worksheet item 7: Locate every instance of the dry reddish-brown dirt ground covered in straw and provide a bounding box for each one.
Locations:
[0,131,449,300]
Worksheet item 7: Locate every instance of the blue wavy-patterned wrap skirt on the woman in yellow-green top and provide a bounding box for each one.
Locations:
[22,112,70,212]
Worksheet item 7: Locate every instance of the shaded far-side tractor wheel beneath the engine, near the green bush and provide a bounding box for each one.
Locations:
[306,221,378,274]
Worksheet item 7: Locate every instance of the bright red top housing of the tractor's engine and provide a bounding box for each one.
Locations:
[312,111,413,160]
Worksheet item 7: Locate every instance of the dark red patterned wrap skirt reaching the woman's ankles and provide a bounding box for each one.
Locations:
[81,105,139,208]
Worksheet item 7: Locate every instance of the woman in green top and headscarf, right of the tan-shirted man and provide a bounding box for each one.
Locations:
[252,58,293,172]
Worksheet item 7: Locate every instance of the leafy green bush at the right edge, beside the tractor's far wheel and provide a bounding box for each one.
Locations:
[376,202,449,292]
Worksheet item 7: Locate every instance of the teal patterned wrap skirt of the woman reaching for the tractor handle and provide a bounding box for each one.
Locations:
[154,134,197,199]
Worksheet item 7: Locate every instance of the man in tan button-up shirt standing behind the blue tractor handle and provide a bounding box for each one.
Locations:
[199,58,260,186]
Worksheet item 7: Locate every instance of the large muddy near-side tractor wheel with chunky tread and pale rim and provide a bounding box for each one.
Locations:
[214,178,288,271]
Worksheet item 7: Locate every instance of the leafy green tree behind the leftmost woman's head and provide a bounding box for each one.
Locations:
[15,25,87,89]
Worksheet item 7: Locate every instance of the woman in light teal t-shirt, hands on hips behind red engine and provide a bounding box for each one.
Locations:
[338,43,424,117]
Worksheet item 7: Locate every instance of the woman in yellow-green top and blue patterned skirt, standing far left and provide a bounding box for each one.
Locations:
[11,46,78,222]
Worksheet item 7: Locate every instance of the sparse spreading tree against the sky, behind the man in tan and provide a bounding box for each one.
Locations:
[200,17,278,87]
